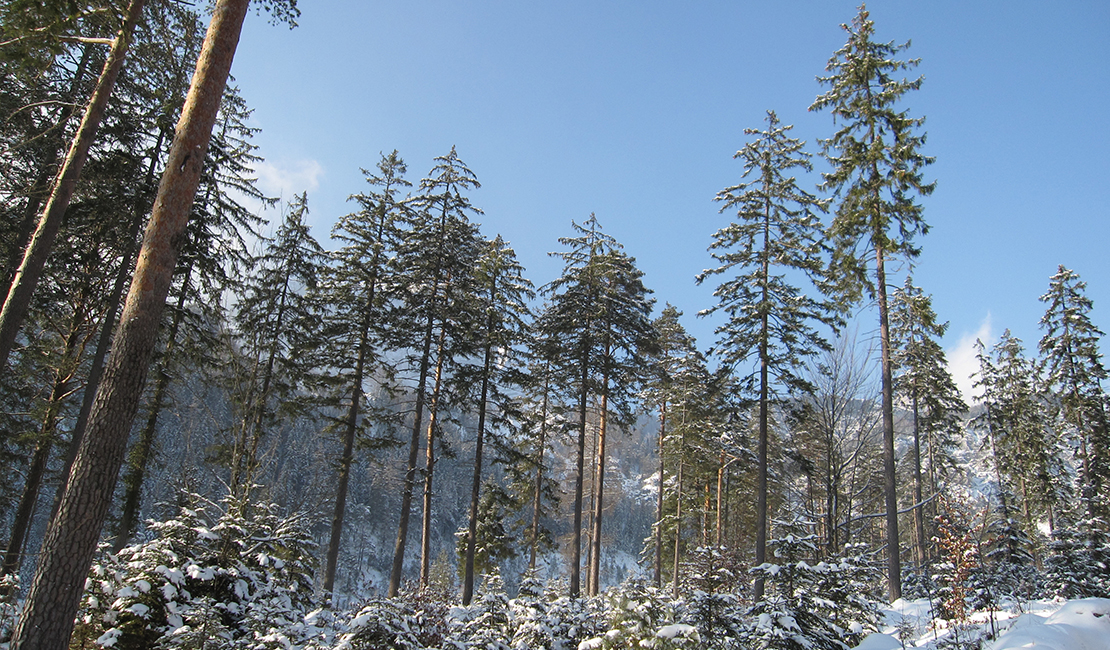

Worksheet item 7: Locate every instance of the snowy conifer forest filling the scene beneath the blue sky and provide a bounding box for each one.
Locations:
[0,0,1110,650]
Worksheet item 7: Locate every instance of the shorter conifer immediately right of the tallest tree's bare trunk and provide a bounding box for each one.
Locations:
[890,277,967,571]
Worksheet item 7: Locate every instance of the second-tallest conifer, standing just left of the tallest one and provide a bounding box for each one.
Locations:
[697,111,839,598]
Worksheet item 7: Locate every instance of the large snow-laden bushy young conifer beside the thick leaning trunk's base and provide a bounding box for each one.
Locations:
[75,495,314,649]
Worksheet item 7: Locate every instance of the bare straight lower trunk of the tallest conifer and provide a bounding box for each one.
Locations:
[875,246,901,602]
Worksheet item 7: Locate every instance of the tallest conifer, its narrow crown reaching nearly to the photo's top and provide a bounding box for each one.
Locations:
[809,6,936,600]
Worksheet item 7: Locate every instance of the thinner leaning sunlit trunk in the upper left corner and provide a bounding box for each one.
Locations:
[0,0,145,373]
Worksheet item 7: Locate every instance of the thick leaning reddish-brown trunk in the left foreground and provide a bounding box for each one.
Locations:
[11,0,249,650]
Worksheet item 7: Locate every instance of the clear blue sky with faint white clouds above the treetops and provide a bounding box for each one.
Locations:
[232,0,1110,399]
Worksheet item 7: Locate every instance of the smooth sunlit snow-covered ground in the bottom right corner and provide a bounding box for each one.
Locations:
[856,598,1110,650]
